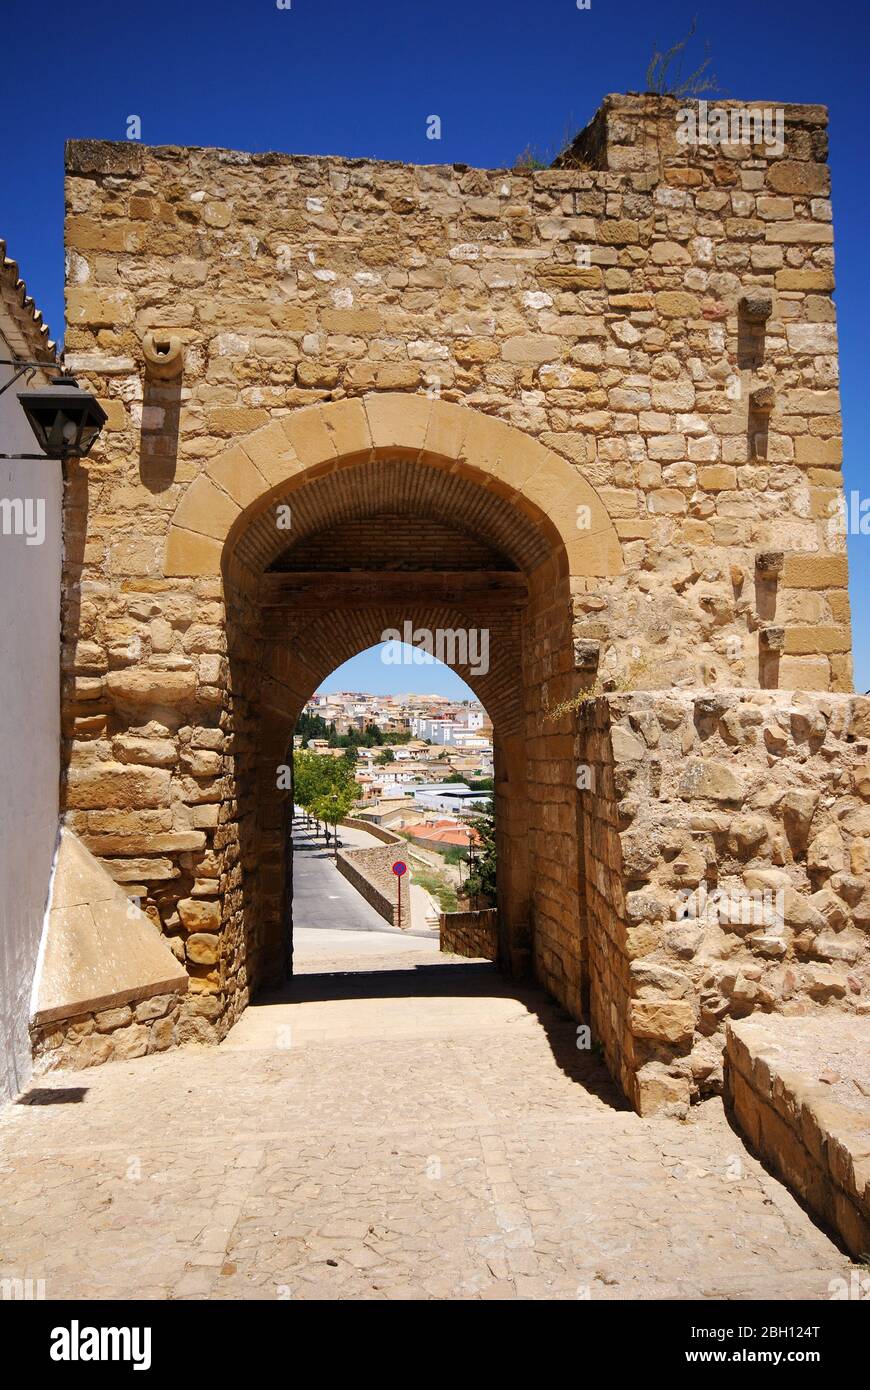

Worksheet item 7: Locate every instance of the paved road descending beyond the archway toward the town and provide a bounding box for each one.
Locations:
[293,823,438,969]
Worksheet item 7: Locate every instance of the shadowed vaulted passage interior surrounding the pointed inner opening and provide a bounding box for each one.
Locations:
[224,444,582,1012]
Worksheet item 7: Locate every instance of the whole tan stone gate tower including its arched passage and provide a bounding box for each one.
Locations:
[54,97,866,1108]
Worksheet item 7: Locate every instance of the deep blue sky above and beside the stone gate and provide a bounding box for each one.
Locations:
[0,0,870,689]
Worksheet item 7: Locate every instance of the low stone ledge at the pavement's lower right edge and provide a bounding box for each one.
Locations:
[725,1015,870,1258]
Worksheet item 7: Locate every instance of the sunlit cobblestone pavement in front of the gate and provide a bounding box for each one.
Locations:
[0,954,851,1298]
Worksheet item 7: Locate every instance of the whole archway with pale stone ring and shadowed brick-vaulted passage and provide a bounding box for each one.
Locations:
[157,396,620,1028]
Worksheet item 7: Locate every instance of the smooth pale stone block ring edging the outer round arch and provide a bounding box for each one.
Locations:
[164,392,623,577]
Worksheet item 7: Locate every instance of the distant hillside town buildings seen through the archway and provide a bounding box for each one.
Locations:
[295,691,493,855]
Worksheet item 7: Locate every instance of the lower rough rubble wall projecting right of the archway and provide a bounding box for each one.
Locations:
[577,691,870,1111]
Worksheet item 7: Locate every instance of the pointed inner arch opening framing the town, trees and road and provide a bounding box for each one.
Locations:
[285,644,496,972]
